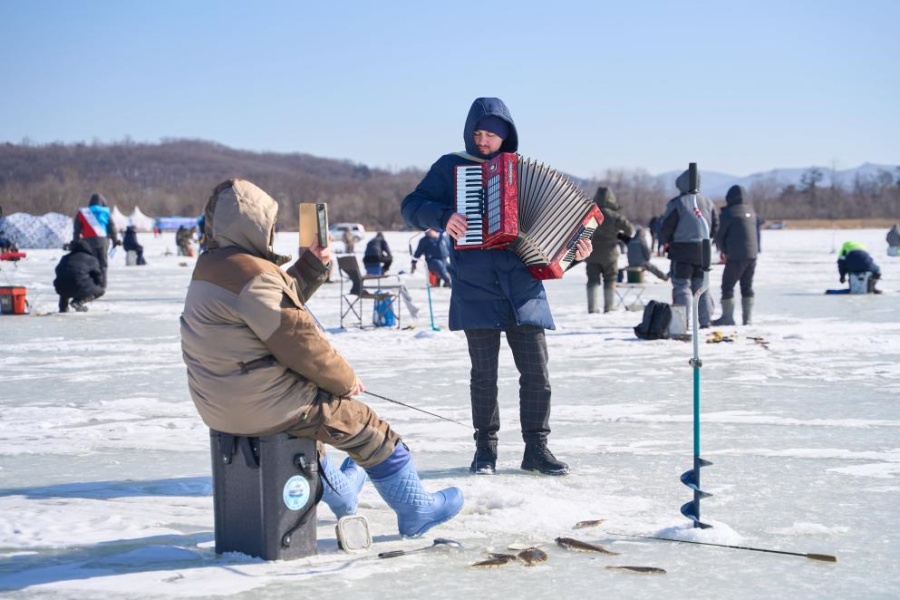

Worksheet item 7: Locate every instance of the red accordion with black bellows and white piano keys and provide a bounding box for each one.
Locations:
[455,153,603,279]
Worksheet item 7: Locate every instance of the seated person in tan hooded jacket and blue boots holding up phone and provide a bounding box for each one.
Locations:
[181,179,463,537]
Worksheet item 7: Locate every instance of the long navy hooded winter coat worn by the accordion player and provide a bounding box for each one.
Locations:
[400,98,556,331]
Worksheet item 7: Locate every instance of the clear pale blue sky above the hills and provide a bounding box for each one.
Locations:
[0,0,900,177]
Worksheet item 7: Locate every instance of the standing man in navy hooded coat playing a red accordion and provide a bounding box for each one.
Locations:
[401,98,591,475]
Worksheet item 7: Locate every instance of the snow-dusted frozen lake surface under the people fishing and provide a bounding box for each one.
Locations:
[0,230,900,600]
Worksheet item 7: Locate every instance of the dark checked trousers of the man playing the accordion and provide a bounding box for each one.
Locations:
[466,325,550,444]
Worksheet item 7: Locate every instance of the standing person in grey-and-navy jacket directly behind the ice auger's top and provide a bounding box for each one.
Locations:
[659,171,719,328]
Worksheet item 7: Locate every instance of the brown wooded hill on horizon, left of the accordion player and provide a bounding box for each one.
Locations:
[0,140,423,229]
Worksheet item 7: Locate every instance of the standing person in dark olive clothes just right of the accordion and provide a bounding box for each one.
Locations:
[584,187,634,313]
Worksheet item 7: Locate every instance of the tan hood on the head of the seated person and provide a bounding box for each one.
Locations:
[204,179,291,265]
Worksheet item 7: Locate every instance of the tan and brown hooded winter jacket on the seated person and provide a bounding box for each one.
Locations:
[181,180,356,435]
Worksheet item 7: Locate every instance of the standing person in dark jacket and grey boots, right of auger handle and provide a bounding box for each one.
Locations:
[713,185,759,325]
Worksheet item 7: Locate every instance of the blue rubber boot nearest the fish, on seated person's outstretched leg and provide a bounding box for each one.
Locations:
[366,444,463,537]
